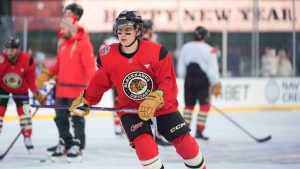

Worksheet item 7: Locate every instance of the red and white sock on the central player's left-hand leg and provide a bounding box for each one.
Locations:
[133,134,163,169]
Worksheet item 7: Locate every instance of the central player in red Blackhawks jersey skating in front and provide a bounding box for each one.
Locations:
[70,11,206,169]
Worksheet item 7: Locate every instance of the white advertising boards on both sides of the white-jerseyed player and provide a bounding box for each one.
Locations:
[177,78,300,111]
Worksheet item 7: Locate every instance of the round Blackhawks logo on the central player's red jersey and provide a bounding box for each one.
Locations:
[122,72,153,100]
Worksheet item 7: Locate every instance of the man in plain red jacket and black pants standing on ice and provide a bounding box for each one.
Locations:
[36,4,96,160]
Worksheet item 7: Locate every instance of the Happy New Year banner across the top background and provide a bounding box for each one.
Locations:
[77,0,300,32]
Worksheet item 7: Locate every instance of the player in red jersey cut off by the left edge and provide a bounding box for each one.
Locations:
[0,37,45,149]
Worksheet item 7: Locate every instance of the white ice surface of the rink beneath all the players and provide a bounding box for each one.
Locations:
[0,111,300,169]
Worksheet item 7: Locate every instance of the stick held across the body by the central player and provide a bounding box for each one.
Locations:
[31,105,138,114]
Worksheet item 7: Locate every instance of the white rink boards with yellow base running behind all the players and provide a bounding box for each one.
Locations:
[5,78,300,120]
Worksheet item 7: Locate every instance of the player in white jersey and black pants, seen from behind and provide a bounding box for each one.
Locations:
[177,26,221,140]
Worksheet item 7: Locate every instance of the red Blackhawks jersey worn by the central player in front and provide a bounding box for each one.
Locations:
[85,41,178,116]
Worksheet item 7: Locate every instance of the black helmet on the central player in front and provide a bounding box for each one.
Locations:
[113,11,143,38]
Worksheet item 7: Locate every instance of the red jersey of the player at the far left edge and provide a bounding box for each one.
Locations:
[0,52,36,94]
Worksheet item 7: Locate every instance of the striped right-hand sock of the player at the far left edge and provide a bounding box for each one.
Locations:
[17,107,32,137]
